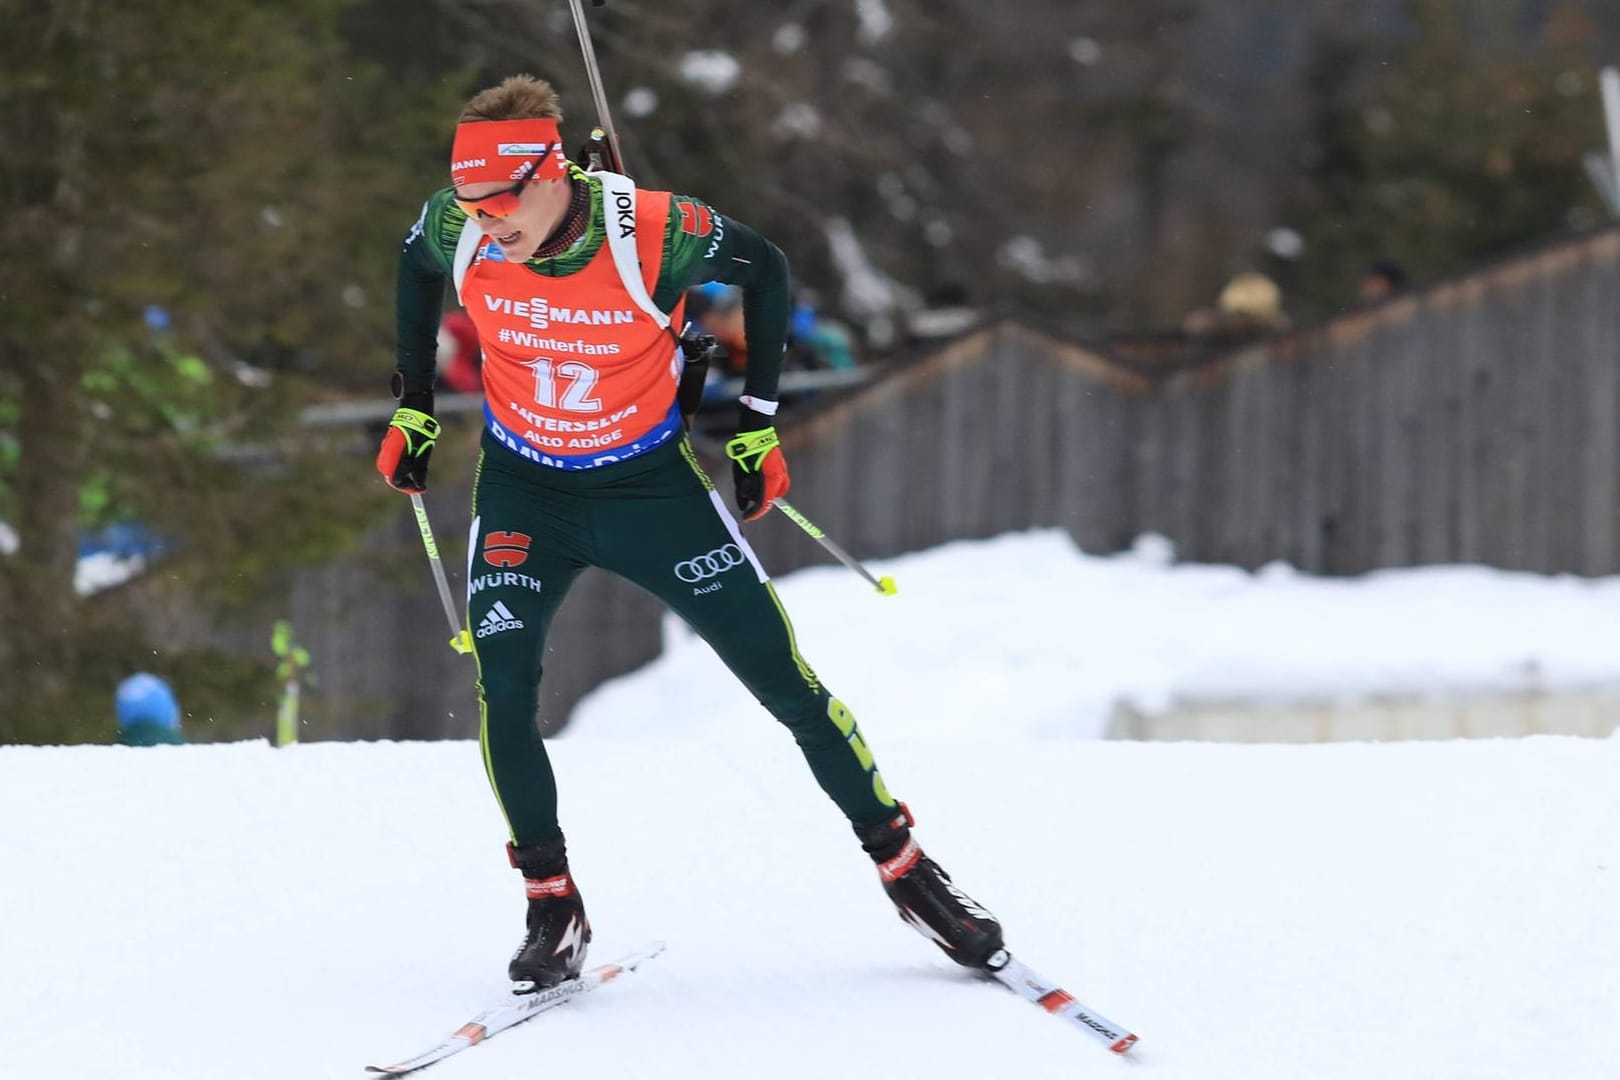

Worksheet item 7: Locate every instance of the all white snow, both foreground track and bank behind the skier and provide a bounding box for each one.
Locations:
[0,533,1620,1080]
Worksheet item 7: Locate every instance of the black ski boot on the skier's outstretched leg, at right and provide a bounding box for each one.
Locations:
[855,803,1001,970]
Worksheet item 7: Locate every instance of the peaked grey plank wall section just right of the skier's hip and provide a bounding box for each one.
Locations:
[738,324,1149,573]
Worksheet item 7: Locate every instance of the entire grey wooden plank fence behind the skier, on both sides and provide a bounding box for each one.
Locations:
[196,230,1620,737]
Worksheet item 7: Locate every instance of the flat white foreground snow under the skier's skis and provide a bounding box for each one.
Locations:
[0,738,1620,1080]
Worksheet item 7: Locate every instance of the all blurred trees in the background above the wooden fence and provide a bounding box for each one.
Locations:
[12,0,1620,738]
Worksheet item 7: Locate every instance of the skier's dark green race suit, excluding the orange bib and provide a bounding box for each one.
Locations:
[399,173,896,847]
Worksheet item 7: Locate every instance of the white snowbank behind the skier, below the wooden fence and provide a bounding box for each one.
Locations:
[570,529,1620,744]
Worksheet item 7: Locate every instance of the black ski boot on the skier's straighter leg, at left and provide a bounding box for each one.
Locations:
[507,840,591,994]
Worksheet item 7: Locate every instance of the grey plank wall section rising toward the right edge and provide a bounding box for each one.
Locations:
[1132,232,1620,573]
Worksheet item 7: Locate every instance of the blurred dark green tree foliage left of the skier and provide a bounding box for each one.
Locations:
[0,0,447,742]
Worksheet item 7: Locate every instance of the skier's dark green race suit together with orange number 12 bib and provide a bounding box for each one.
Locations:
[399,170,896,847]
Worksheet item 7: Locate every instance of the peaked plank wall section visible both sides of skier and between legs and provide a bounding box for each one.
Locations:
[281,324,1147,738]
